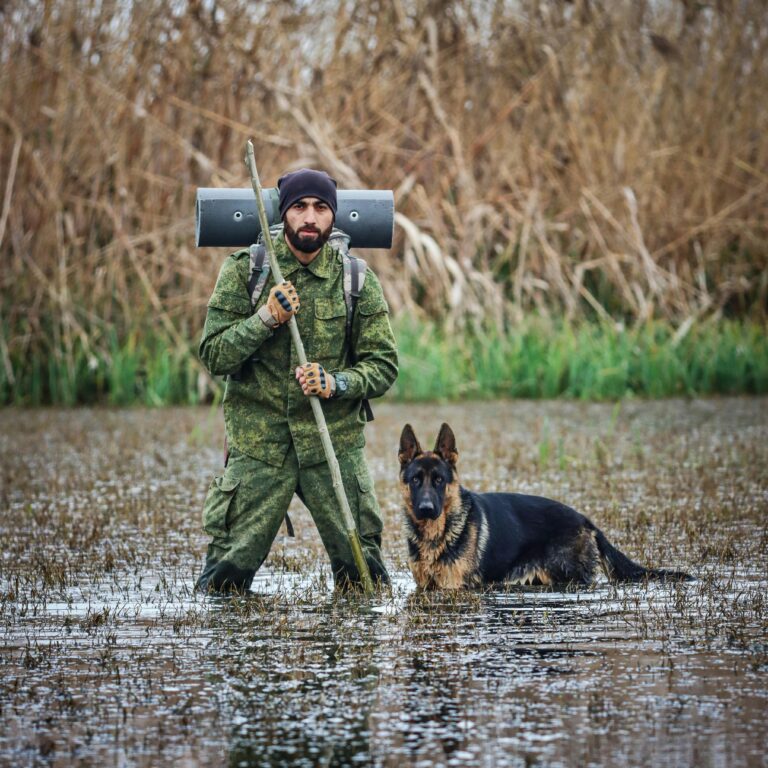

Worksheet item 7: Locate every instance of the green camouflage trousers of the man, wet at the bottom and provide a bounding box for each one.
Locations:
[197,448,389,591]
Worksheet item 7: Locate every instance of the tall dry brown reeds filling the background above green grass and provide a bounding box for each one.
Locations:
[0,0,768,380]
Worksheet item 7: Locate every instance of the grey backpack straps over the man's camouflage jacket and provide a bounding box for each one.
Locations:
[242,224,373,421]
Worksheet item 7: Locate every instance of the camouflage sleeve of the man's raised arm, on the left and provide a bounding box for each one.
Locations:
[199,252,272,376]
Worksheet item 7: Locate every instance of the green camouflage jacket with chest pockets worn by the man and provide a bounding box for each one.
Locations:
[200,236,397,466]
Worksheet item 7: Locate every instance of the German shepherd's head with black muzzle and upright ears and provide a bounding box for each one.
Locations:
[398,424,459,522]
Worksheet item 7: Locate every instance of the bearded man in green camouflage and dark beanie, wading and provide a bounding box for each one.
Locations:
[197,169,397,591]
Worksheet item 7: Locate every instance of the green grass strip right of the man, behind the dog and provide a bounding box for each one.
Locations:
[393,319,768,401]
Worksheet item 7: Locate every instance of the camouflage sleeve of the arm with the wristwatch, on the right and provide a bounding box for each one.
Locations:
[340,269,397,399]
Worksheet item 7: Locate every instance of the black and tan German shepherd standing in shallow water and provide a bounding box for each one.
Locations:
[398,424,691,589]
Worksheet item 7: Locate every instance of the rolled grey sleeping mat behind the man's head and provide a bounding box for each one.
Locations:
[195,187,395,248]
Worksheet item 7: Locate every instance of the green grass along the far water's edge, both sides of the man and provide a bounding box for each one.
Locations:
[0,319,768,408]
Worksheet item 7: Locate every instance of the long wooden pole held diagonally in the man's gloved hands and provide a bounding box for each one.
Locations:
[245,139,373,595]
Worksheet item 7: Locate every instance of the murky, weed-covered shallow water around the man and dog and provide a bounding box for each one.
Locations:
[0,399,768,766]
